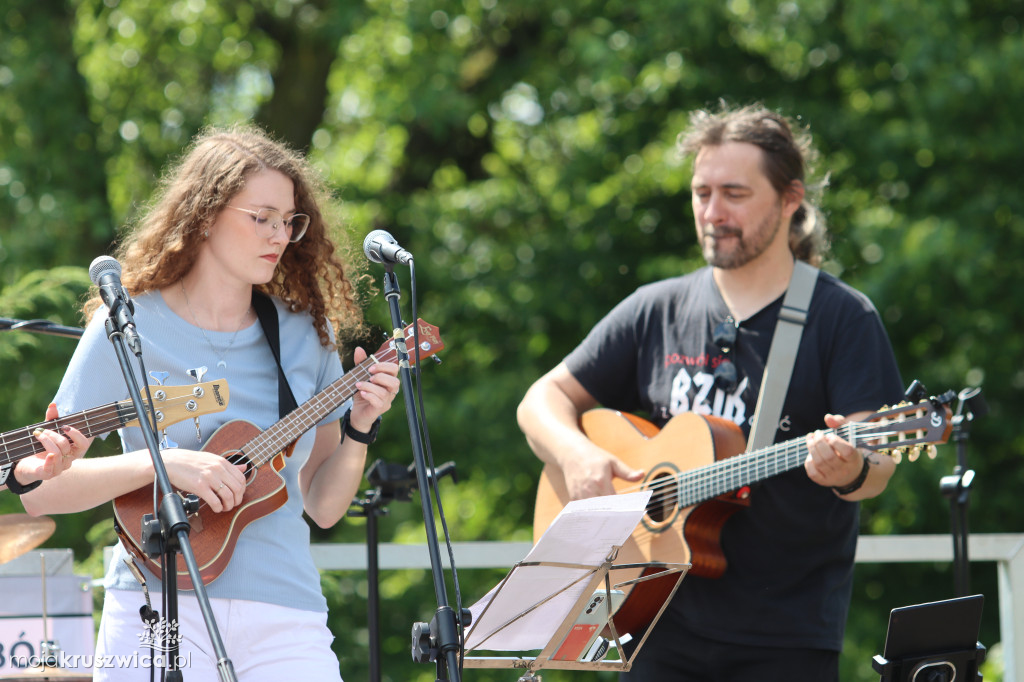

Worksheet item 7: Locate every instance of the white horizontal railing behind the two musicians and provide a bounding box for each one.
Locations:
[312,534,1024,682]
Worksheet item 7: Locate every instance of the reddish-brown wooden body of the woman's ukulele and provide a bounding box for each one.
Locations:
[114,420,292,590]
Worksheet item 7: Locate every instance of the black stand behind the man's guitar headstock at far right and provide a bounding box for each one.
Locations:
[939,388,988,597]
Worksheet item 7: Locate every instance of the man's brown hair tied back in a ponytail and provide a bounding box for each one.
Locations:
[677,101,828,266]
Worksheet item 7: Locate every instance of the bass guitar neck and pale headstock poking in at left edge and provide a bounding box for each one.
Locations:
[0,381,228,477]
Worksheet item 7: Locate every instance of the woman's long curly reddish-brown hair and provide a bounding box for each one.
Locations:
[82,124,361,347]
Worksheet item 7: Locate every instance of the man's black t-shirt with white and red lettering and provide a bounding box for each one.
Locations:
[565,267,903,650]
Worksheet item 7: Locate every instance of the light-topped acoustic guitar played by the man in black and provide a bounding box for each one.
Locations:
[534,399,952,633]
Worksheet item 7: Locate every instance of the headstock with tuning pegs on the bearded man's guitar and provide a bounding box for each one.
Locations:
[852,398,952,463]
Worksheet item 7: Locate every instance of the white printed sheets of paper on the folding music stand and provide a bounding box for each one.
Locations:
[466,491,651,651]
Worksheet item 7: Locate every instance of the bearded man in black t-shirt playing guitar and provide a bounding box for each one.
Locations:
[518,105,902,682]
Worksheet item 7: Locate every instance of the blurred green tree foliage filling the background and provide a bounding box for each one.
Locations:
[0,0,1024,680]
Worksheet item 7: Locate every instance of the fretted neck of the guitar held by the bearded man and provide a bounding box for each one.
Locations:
[677,425,855,507]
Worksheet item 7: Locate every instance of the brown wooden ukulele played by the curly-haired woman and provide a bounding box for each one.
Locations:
[114,319,444,590]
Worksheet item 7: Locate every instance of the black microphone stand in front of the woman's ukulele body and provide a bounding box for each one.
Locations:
[98,311,238,682]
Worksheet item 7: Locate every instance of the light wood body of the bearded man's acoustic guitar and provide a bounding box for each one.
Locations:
[534,409,749,634]
